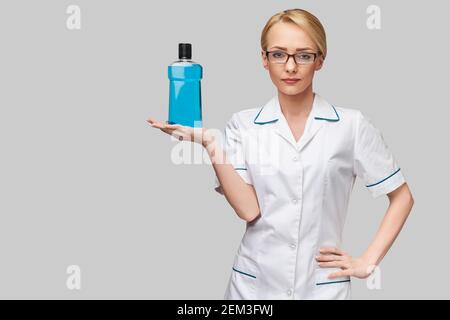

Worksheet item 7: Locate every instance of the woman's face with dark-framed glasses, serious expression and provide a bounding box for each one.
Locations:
[261,22,323,95]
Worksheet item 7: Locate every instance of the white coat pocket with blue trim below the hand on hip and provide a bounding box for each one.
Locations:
[314,268,351,300]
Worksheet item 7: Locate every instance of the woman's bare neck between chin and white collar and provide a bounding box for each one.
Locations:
[278,86,314,119]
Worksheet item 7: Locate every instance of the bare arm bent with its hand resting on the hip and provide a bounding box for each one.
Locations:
[316,183,414,278]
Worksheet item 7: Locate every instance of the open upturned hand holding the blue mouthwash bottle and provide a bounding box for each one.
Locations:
[147,118,214,147]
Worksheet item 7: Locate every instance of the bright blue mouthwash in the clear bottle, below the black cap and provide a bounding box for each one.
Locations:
[167,61,203,128]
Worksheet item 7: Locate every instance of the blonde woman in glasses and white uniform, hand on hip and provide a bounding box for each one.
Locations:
[147,9,413,299]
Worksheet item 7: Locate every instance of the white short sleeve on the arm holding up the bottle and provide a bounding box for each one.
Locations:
[214,113,253,194]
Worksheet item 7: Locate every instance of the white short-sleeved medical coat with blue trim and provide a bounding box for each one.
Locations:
[215,93,405,299]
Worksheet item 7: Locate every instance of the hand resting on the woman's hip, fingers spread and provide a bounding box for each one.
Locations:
[316,247,375,279]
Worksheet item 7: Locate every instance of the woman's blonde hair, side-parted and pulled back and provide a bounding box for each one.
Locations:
[261,9,327,59]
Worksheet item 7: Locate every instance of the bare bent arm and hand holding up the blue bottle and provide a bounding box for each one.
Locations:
[147,118,260,222]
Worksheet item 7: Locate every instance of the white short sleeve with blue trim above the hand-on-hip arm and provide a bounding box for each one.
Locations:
[354,111,405,198]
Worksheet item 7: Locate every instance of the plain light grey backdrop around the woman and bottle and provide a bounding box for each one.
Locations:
[0,0,450,299]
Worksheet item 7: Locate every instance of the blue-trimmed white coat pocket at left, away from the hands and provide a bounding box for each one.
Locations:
[226,254,259,300]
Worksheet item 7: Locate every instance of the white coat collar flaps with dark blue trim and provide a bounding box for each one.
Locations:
[253,93,340,125]
